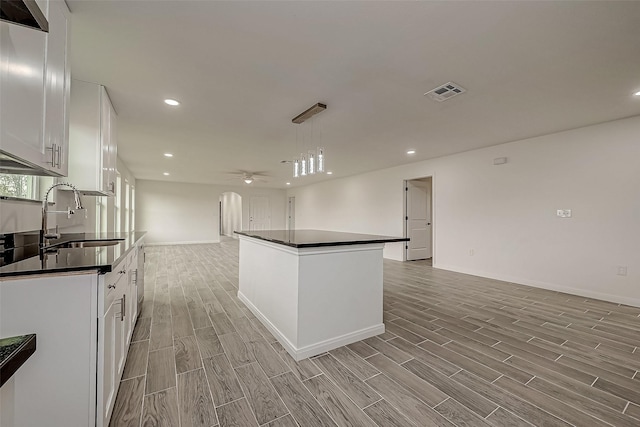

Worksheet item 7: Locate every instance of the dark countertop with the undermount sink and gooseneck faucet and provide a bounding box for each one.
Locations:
[0,232,146,278]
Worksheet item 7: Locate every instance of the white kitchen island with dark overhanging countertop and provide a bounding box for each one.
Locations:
[236,230,409,360]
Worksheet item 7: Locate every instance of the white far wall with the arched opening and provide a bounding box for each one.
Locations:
[136,180,286,244]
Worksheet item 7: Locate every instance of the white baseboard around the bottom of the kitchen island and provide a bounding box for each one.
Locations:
[238,291,385,362]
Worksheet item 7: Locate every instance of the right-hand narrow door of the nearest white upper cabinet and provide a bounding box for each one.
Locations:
[44,1,71,176]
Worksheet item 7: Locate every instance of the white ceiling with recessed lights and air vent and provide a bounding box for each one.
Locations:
[67,0,640,188]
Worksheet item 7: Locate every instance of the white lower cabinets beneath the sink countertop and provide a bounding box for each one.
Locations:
[0,248,137,427]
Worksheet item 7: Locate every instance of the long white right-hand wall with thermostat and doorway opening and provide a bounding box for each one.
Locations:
[288,113,640,306]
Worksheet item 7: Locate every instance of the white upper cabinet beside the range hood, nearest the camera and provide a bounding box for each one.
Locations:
[0,0,71,176]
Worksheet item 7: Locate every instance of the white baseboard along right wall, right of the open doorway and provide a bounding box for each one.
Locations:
[434,264,640,307]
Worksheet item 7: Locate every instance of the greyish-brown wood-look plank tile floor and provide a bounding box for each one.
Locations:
[111,240,640,427]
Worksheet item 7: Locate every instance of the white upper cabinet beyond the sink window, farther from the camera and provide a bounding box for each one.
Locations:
[68,80,117,196]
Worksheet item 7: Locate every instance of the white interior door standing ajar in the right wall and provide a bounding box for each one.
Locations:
[406,180,432,261]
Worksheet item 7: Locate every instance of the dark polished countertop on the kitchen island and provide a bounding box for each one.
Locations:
[235,230,409,248]
